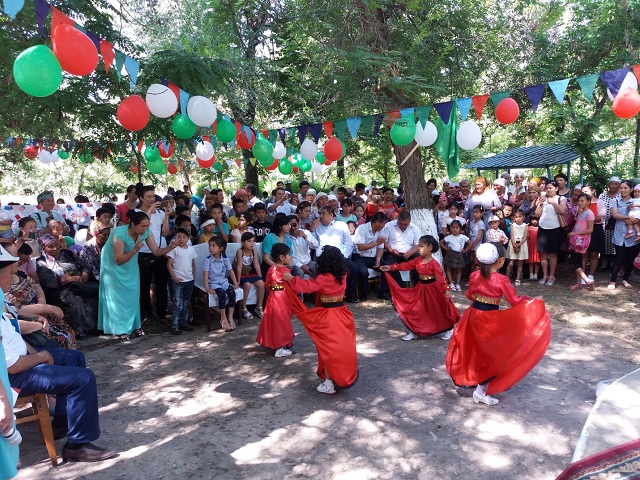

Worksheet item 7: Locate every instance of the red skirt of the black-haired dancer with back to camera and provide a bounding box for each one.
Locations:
[285,285,358,388]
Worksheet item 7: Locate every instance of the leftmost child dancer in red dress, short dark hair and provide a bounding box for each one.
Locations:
[256,243,295,358]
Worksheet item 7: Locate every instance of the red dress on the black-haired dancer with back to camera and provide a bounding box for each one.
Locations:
[287,273,358,388]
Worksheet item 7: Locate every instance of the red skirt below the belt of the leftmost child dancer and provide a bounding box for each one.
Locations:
[256,290,295,350]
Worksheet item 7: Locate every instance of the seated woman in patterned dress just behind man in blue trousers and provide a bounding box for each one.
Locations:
[5,263,76,349]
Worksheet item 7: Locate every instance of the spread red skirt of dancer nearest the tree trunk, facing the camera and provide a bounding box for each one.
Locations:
[385,272,460,336]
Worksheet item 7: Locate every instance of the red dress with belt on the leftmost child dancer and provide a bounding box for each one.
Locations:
[256,265,295,350]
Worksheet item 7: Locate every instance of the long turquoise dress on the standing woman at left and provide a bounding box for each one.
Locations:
[98,225,151,335]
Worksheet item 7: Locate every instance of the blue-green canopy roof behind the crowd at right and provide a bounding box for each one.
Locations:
[464,138,627,181]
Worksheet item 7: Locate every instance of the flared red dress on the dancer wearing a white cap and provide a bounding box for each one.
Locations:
[446,271,551,395]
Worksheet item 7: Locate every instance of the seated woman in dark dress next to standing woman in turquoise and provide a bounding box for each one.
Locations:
[36,234,98,340]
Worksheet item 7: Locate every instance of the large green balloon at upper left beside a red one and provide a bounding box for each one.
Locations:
[13,45,62,97]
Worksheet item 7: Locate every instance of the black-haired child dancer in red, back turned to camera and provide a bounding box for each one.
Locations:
[284,246,358,395]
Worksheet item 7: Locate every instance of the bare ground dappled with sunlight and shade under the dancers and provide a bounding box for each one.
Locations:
[12,275,640,480]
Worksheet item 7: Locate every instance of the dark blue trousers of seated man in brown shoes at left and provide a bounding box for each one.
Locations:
[9,348,100,443]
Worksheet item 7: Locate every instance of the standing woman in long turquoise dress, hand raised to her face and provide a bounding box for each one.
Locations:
[98,210,176,341]
